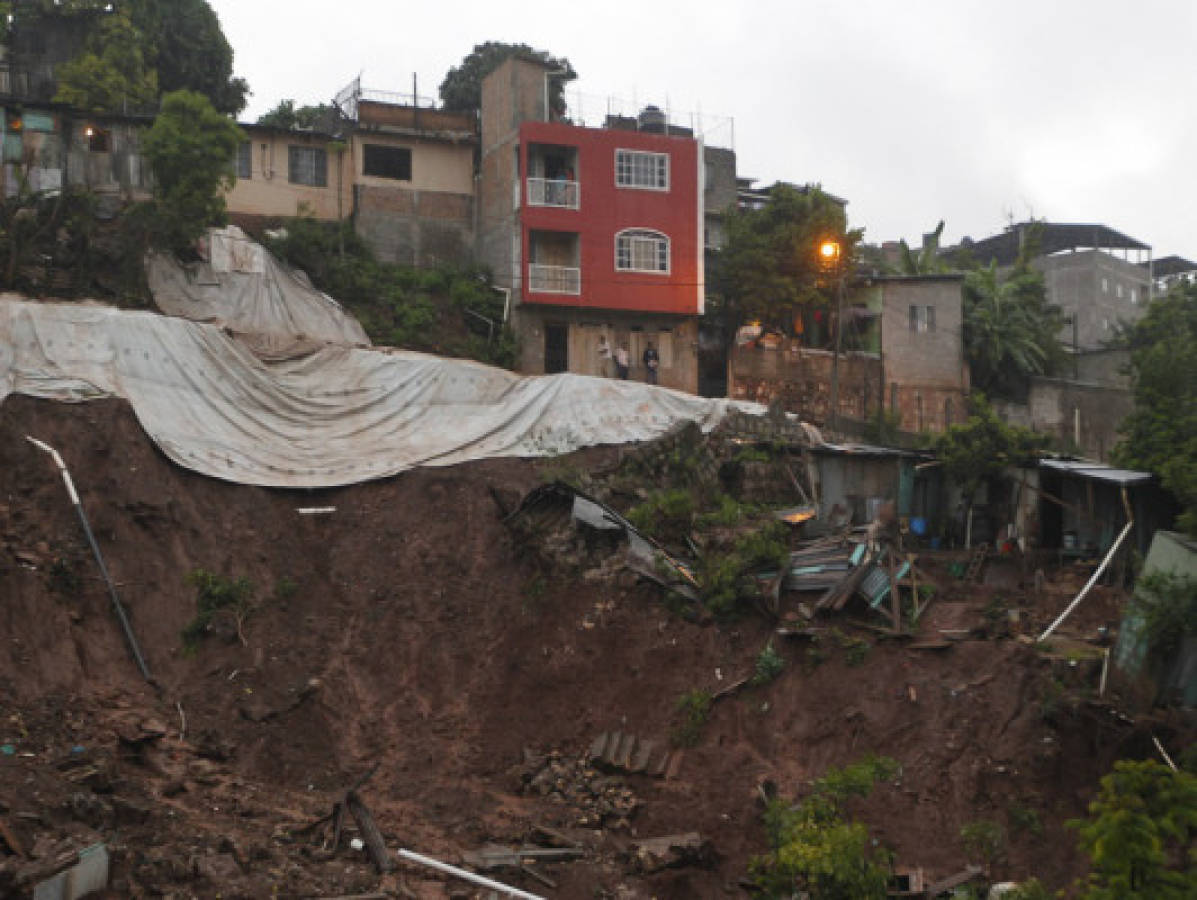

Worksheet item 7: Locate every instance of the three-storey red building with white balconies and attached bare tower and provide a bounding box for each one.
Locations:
[476,57,705,391]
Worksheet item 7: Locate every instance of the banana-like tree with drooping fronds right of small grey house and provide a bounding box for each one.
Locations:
[964,259,1064,397]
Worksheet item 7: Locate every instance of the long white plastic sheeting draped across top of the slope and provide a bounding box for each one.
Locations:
[0,296,765,487]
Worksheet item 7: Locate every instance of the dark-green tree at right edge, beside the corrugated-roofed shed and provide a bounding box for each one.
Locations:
[1114,285,1197,537]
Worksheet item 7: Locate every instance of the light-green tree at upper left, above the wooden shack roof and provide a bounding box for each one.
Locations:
[54,11,158,113]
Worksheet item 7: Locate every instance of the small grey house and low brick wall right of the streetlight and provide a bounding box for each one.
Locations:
[728,274,968,432]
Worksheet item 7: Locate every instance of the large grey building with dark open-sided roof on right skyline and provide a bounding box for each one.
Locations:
[944,221,1154,351]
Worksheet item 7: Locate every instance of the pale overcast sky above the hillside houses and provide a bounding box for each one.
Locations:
[209,0,1197,259]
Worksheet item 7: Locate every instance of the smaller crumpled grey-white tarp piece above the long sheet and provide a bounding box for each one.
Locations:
[146,225,370,357]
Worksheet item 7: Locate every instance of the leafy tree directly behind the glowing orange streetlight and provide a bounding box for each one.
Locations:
[712,184,862,336]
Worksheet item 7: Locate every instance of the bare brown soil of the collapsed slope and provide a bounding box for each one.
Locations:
[0,396,1187,898]
